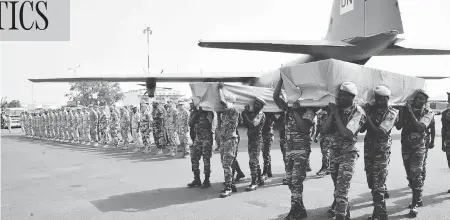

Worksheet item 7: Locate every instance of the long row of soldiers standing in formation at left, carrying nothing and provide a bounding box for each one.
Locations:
[21,101,189,157]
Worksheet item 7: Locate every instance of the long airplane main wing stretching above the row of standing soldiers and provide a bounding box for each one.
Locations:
[28,73,261,83]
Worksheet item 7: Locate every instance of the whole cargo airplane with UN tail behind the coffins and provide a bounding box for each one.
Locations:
[29,0,450,97]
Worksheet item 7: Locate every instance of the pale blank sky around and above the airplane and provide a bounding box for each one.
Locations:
[0,0,450,105]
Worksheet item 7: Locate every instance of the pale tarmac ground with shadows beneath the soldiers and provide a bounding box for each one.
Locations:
[1,117,450,220]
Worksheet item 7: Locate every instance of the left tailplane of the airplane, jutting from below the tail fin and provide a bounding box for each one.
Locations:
[198,40,354,55]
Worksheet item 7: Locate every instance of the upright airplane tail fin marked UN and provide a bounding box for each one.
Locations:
[325,0,403,41]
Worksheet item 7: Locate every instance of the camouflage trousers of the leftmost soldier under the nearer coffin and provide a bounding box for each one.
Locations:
[286,150,308,204]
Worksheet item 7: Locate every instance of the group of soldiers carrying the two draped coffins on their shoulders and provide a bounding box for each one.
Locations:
[188,79,450,219]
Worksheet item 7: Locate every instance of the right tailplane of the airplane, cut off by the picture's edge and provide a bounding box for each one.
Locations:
[375,39,450,56]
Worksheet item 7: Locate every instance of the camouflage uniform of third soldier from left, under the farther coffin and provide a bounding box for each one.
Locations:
[247,111,266,190]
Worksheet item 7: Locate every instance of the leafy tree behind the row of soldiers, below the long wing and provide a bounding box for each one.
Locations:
[65,82,124,106]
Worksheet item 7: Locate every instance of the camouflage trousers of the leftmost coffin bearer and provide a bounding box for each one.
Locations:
[190,135,213,175]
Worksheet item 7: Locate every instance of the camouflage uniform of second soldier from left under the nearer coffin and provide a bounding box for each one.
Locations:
[330,104,367,219]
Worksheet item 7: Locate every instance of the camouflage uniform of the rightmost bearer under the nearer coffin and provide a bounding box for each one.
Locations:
[401,106,434,206]
